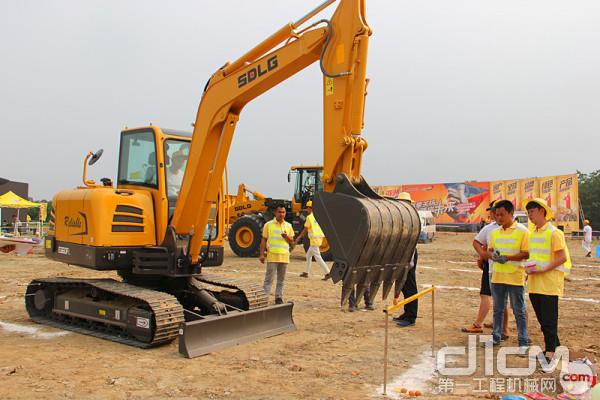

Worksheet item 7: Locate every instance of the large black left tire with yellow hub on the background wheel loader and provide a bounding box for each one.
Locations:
[227,215,265,257]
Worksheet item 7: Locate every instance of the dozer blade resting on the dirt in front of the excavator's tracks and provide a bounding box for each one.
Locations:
[179,303,296,358]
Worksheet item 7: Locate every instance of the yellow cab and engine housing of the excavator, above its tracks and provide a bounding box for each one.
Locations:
[45,126,224,274]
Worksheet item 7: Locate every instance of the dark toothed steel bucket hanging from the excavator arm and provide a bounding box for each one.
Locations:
[313,174,421,305]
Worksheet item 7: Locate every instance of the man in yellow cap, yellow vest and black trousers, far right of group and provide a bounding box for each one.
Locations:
[523,198,571,361]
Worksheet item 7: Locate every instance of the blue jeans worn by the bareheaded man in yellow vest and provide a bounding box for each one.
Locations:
[492,283,529,346]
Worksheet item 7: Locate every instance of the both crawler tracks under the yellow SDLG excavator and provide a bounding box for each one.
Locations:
[25,274,267,348]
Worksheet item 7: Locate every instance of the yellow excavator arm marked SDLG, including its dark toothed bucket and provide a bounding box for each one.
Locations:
[171,0,420,304]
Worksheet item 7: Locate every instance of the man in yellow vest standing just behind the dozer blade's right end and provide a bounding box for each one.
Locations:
[258,204,294,304]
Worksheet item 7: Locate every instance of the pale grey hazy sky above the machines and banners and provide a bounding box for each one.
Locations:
[0,0,600,199]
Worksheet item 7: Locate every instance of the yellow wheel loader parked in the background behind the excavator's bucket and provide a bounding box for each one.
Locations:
[227,165,333,261]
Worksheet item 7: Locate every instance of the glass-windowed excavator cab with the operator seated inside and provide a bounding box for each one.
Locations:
[117,126,224,266]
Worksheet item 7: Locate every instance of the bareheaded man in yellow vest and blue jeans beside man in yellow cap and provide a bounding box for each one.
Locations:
[488,200,529,350]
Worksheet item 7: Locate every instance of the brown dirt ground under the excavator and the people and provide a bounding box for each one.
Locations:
[0,233,600,399]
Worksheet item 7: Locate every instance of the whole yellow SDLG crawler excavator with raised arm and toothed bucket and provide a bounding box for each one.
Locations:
[25,0,420,357]
